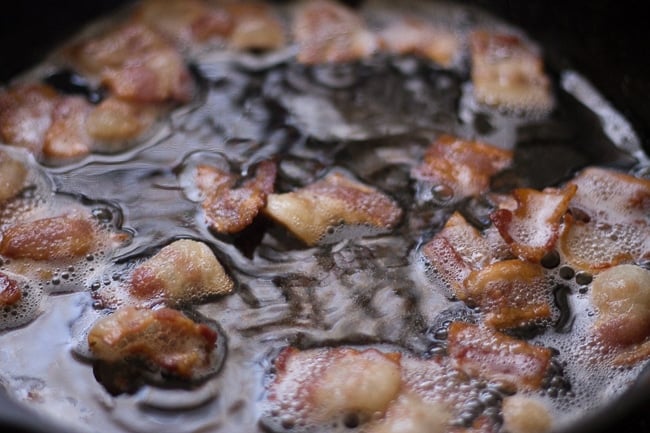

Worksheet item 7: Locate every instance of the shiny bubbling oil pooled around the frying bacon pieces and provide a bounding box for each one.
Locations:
[0,2,642,433]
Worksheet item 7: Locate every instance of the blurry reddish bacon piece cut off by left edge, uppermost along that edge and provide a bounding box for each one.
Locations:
[0,84,58,155]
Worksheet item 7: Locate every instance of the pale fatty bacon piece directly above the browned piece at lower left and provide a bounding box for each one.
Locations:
[129,239,234,303]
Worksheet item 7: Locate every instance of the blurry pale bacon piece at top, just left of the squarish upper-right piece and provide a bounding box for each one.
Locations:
[380,16,461,67]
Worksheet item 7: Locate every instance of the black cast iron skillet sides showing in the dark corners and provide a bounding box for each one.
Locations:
[0,0,650,433]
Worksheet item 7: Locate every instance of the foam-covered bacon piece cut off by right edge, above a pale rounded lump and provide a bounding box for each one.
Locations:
[559,168,650,272]
